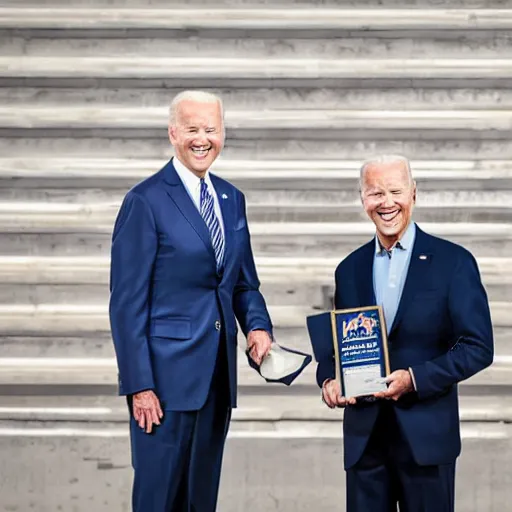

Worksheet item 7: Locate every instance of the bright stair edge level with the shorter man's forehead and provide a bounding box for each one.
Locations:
[0,156,512,179]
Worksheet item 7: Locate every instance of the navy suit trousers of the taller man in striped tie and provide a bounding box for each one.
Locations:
[130,337,231,512]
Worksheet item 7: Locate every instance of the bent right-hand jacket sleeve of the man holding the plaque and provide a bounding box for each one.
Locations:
[412,252,494,400]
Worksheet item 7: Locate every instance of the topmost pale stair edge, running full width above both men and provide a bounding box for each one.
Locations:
[0,7,512,31]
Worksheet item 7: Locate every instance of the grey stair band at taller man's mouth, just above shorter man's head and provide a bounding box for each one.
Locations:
[0,138,512,160]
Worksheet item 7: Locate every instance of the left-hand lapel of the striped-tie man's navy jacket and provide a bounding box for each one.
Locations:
[164,160,215,258]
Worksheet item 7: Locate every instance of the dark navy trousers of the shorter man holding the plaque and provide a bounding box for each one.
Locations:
[347,402,455,512]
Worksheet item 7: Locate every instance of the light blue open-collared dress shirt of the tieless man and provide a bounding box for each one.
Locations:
[373,222,416,334]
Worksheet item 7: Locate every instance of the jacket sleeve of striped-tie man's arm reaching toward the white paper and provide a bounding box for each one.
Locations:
[233,193,272,336]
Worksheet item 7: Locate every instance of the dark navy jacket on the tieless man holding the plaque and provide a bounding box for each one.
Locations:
[317,227,493,468]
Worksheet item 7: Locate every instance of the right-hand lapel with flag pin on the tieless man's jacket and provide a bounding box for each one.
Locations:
[390,226,433,334]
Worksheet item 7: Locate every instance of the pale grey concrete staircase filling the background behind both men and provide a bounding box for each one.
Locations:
[0,0,512,512]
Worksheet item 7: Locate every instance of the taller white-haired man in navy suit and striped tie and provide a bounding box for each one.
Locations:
[110,91,272,512]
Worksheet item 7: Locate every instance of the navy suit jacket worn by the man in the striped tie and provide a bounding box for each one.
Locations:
[110,161,272,411]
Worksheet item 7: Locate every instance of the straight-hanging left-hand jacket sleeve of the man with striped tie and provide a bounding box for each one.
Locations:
[109,192,158,395]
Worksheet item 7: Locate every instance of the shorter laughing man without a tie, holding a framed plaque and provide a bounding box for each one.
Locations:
[317,156,493,512]
